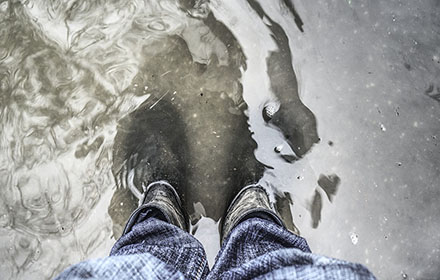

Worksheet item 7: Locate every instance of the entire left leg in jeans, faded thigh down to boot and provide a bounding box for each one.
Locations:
[56,182,209,280]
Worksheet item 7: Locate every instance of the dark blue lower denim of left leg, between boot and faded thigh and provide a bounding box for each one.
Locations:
[110,210,209,279]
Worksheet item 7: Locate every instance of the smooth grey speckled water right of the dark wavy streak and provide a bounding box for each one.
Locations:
[278,1,440,279]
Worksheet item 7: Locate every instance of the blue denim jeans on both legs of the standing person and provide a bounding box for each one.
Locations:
[56,210,375,280]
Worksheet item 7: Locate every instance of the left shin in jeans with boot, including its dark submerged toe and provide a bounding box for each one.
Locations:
[110,96,208,279]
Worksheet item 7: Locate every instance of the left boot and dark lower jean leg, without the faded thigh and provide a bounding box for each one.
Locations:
[110,182,209,279]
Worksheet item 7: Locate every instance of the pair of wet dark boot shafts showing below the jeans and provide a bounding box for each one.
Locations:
[123,181,294,244]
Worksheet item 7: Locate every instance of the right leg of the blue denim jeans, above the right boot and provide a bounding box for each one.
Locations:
[208,217,375,279]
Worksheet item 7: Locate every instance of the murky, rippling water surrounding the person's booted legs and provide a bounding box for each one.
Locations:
[0,0,440,279]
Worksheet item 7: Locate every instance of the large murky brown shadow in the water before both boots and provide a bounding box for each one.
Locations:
[109,37,264,237]
